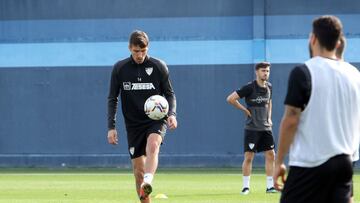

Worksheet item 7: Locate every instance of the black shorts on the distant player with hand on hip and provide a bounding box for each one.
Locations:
[244,130,275,152]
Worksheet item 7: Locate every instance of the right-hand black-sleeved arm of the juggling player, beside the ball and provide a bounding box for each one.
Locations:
[159,61,177,129]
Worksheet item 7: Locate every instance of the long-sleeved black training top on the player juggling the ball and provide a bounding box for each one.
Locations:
[108,56,176,129]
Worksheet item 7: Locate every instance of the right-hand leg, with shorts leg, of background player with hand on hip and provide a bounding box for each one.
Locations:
[258,131,277,193]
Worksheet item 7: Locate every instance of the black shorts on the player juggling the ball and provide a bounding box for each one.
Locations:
[126,120,167,159]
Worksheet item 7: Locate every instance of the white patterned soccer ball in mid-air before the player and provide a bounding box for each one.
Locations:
[144,95,169,120]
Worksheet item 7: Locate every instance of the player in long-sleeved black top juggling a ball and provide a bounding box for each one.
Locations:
[107,30,177,203]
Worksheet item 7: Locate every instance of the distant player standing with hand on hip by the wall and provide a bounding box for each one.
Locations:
[227,62,277,195]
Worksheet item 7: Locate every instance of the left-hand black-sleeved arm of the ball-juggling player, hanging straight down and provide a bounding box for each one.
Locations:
[107,66,120,144]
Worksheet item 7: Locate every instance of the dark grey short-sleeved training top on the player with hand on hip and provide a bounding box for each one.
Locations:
[236,80,272,131]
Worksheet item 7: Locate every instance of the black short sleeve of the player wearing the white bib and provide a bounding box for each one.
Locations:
[284,64,311,111]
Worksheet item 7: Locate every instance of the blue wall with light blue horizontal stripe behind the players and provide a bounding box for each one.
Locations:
[0,0,360,167]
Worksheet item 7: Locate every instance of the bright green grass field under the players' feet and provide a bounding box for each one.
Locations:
[0,169,360,203]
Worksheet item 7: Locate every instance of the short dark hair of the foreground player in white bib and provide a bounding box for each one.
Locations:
[313,15,342,51]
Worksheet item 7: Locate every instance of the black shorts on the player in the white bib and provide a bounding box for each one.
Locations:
[280,155,353,203]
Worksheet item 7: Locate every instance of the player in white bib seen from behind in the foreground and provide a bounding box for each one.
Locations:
[274,16,360,203]
